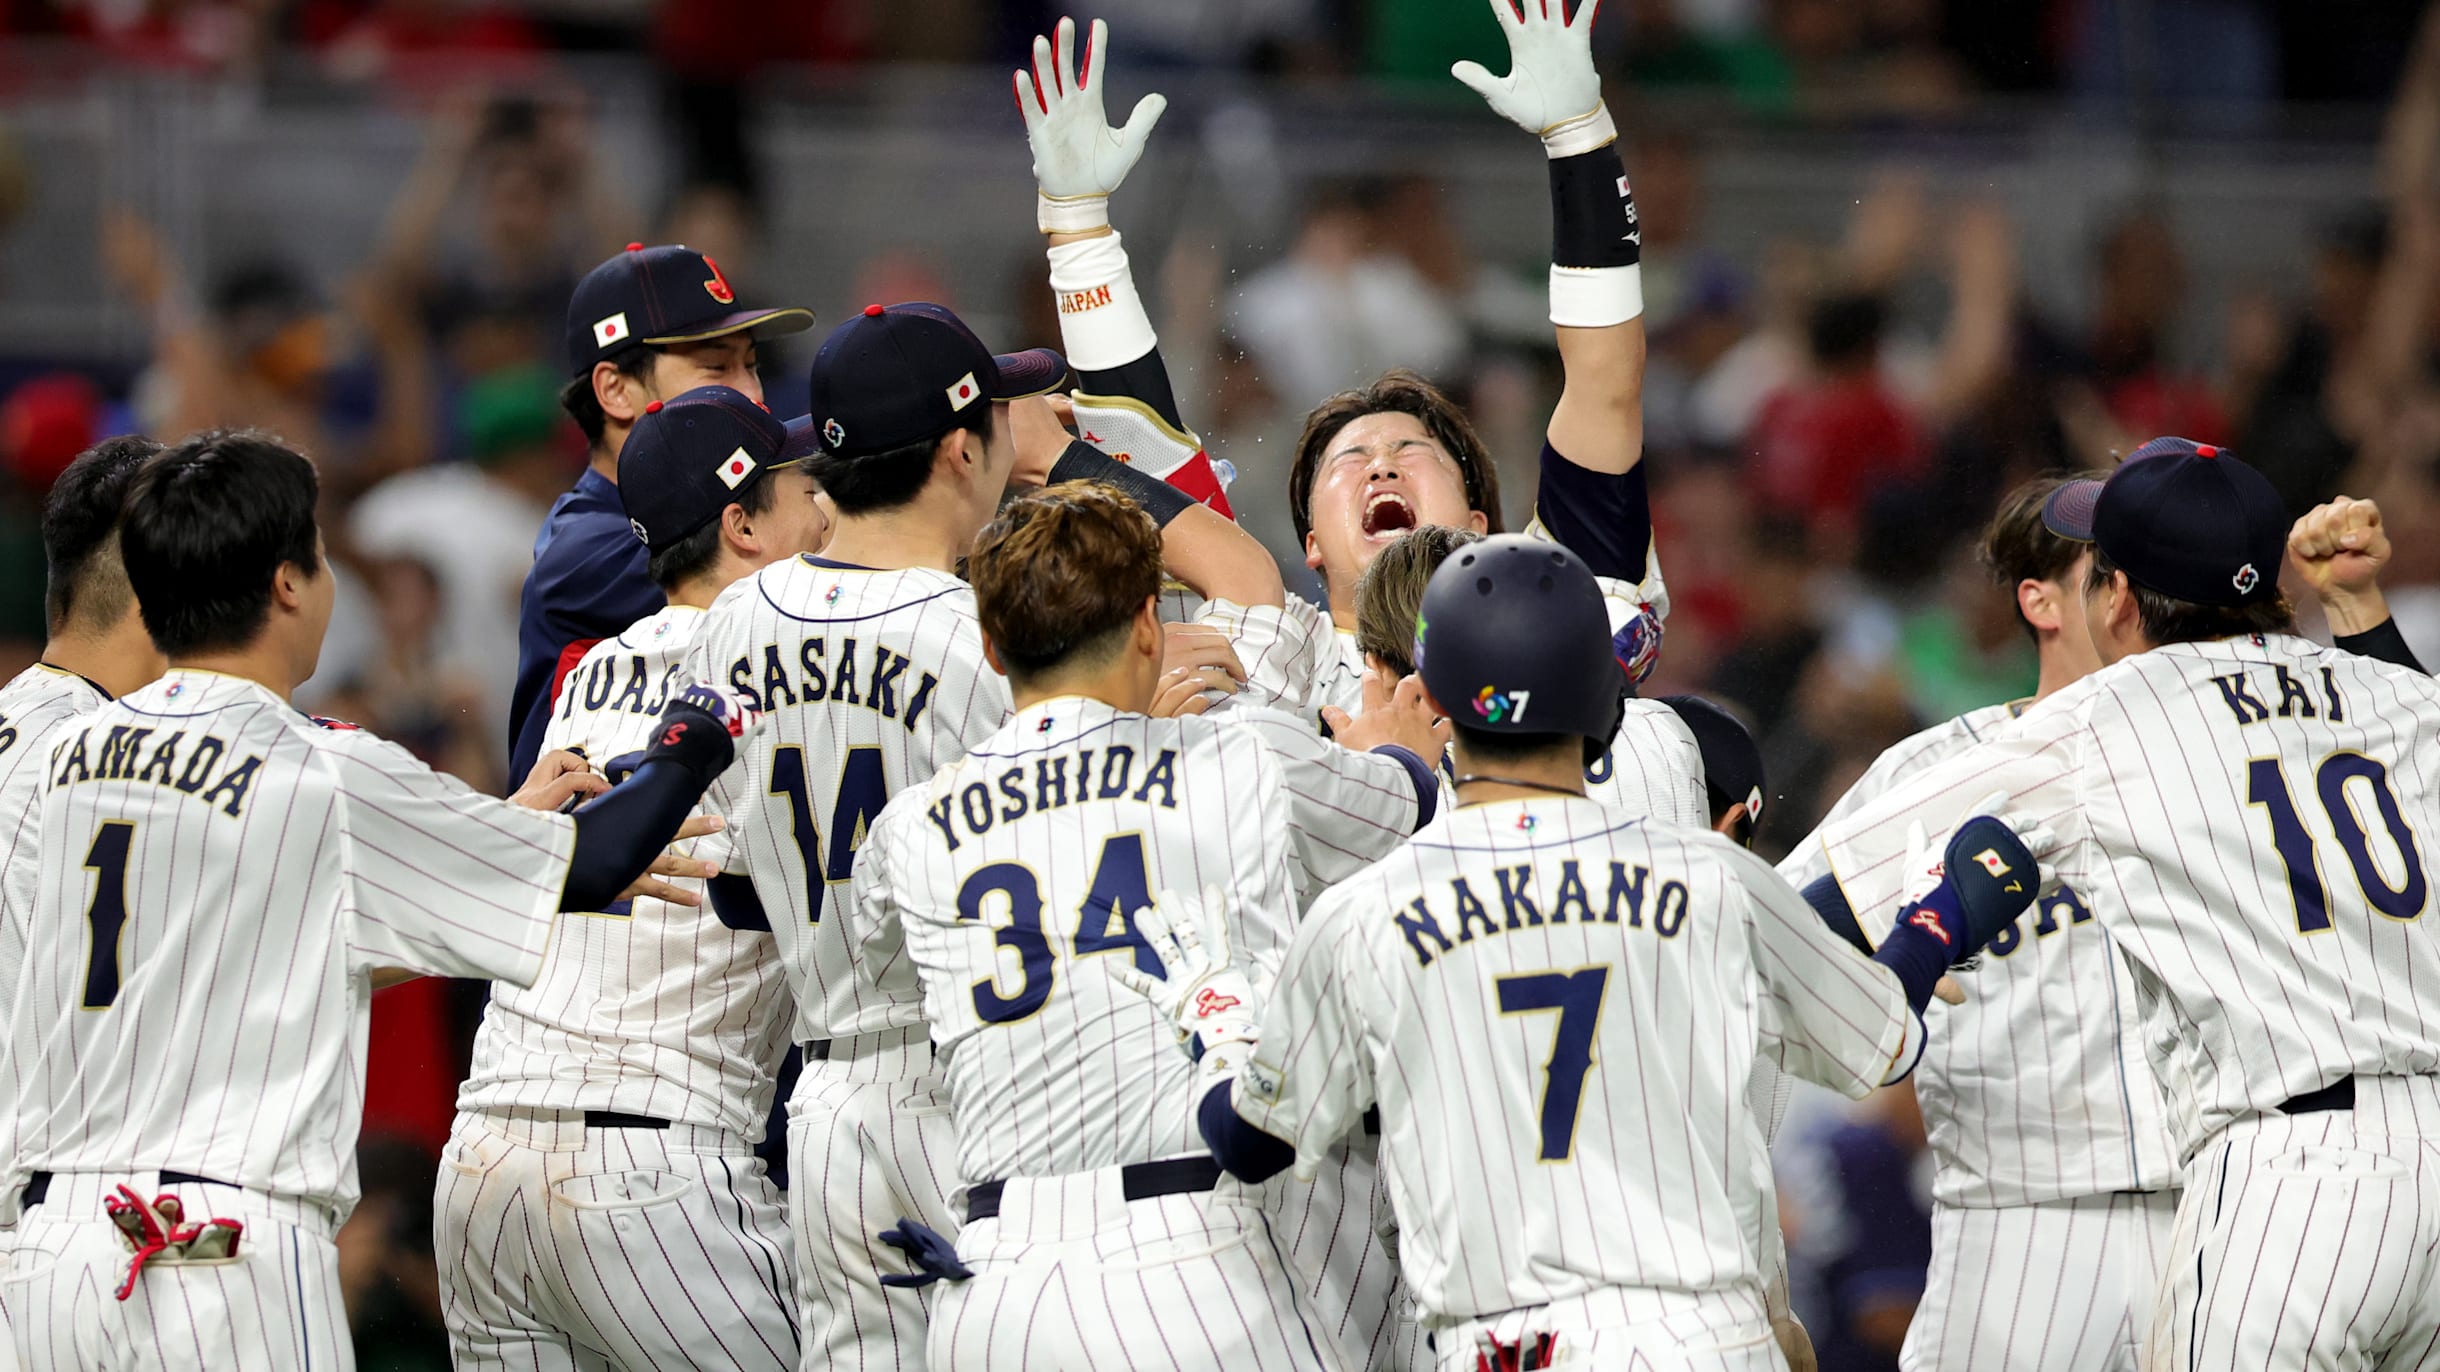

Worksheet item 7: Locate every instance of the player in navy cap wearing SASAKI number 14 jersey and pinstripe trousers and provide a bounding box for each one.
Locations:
[686,305,1279,1367]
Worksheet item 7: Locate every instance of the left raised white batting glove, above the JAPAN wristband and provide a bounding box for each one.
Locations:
[1017,20,1169,234]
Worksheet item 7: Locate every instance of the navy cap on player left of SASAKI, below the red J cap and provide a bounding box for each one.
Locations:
[617,386,805,552]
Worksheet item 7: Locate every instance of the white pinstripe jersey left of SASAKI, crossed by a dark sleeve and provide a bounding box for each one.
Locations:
[459,605,795,1140]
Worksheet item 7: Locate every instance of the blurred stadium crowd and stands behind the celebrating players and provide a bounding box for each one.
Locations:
[0,0,2440,1370]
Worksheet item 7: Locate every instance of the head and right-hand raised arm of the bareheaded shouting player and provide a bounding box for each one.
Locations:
[1288,0,1669,710]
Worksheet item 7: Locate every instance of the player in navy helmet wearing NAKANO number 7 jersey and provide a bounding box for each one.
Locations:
[1139,537,2037,1372]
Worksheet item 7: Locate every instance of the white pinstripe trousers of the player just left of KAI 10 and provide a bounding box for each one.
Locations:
[1898,1186,2176,1372]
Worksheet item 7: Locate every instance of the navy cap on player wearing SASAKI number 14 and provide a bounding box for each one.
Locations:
[808,303,1069,457]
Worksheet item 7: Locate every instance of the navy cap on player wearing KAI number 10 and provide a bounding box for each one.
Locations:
[2042,437,2291,605]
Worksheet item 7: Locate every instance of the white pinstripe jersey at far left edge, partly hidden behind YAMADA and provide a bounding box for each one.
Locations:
[0,662,110,1186]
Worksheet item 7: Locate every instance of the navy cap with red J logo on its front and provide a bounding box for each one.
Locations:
[569,244,813,376]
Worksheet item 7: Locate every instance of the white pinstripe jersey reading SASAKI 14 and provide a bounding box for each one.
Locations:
[686,557,1010,1042]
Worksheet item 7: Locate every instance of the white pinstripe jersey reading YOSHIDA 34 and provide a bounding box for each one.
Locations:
[856,696,1418,1182]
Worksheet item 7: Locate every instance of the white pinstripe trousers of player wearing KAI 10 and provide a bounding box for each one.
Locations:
[2142,1077,2440,1372]
